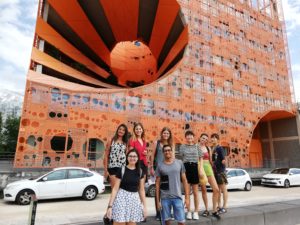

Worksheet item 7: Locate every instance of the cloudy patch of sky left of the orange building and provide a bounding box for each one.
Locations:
[0,0,38,91]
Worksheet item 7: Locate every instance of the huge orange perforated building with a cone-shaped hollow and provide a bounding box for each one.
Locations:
[14,0,300,168]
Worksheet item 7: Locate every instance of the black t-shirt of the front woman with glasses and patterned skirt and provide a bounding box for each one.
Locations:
[116,166,143,192]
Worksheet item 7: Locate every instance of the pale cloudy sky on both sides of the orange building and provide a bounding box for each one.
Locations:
[0,0,300,102]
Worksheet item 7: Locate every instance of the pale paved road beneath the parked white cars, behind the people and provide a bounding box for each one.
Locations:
[0,186,300,225]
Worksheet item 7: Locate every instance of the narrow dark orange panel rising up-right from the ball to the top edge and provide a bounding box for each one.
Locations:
[149,0,179,59]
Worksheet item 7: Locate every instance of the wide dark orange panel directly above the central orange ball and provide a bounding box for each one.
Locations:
[99,0,139,42]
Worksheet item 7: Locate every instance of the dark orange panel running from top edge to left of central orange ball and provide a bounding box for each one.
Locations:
[48,0,110,65]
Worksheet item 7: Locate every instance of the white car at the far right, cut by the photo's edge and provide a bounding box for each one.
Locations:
[261,168,300,188]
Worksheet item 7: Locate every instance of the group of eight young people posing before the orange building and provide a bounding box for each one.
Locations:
[103,123,228,225]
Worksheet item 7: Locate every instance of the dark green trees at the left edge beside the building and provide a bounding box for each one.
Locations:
[0,115,20,156]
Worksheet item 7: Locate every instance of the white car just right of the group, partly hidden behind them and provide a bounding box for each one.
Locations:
[206,168,252,191]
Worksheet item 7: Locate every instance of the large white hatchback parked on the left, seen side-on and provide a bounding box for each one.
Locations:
[3,167,105,205]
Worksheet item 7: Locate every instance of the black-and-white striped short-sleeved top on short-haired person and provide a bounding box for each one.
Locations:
[179,144,203,163]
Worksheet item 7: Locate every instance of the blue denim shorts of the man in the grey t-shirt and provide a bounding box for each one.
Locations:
[161,198,185,223]
